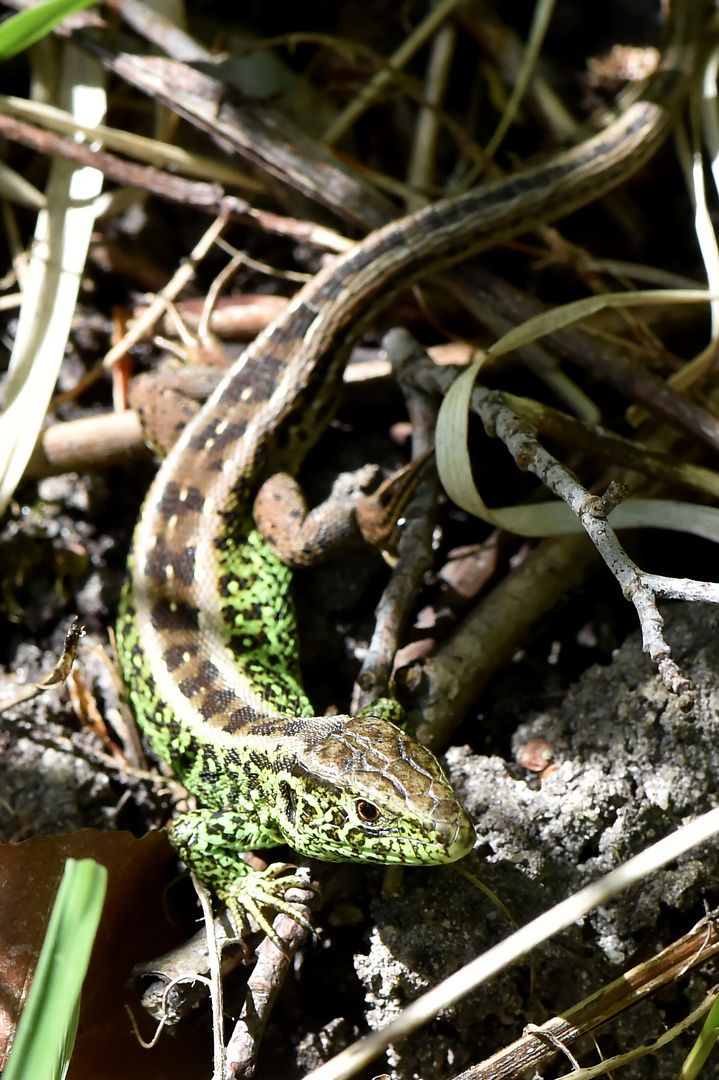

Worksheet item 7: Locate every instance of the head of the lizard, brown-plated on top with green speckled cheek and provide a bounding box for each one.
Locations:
[277,716,474,865]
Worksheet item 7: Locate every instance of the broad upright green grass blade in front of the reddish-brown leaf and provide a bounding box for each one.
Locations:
[3,859,107,1080]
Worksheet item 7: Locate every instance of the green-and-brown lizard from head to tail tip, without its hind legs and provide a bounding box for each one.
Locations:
[117,0,697,936]
